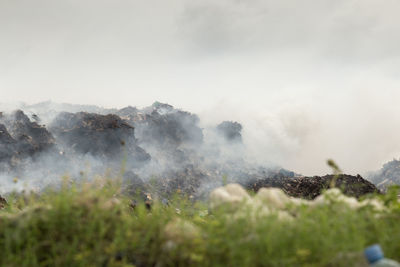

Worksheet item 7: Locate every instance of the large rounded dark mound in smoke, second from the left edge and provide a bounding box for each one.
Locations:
[50,112,150,166]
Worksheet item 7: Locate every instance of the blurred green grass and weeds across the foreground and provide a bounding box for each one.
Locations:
[0,181,400,266]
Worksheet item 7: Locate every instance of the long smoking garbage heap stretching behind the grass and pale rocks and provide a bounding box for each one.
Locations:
[0,102,376,201]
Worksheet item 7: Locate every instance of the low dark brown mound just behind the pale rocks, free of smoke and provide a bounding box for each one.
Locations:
[244,174,379,199]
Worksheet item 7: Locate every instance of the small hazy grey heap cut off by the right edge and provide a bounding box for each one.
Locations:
[367,159,400,190]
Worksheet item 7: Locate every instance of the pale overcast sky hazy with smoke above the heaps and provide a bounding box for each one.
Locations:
[0,0,400,175]
